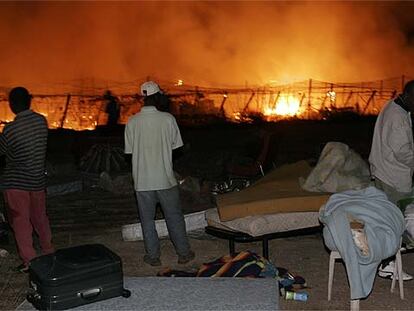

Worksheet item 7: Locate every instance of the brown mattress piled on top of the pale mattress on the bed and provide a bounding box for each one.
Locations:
[216,161,330,221]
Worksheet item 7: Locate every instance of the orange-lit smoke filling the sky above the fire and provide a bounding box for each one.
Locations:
[0,1,414,90]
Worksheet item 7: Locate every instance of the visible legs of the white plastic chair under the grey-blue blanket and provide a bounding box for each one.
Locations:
[328,249,404,311]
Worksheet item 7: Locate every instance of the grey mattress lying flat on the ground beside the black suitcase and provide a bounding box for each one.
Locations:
[17,277,279,311]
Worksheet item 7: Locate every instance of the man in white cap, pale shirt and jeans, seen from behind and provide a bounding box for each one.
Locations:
[125,81,195,266]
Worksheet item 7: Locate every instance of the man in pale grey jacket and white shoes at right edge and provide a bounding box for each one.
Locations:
[369,80,414,281]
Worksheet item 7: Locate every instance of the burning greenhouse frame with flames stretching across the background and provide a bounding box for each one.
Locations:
[0,76,409,130]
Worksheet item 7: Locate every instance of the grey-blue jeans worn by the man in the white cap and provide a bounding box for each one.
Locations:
[136,186,191,258]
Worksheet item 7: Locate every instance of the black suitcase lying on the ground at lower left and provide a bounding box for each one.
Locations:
[27,244,131,310]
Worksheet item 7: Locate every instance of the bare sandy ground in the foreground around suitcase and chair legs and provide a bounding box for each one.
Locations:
[0,221,414,310]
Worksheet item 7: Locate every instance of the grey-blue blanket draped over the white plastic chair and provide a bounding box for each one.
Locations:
[320,187,404,299]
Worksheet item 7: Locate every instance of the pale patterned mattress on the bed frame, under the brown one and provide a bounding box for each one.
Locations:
[206,208,319,236]
